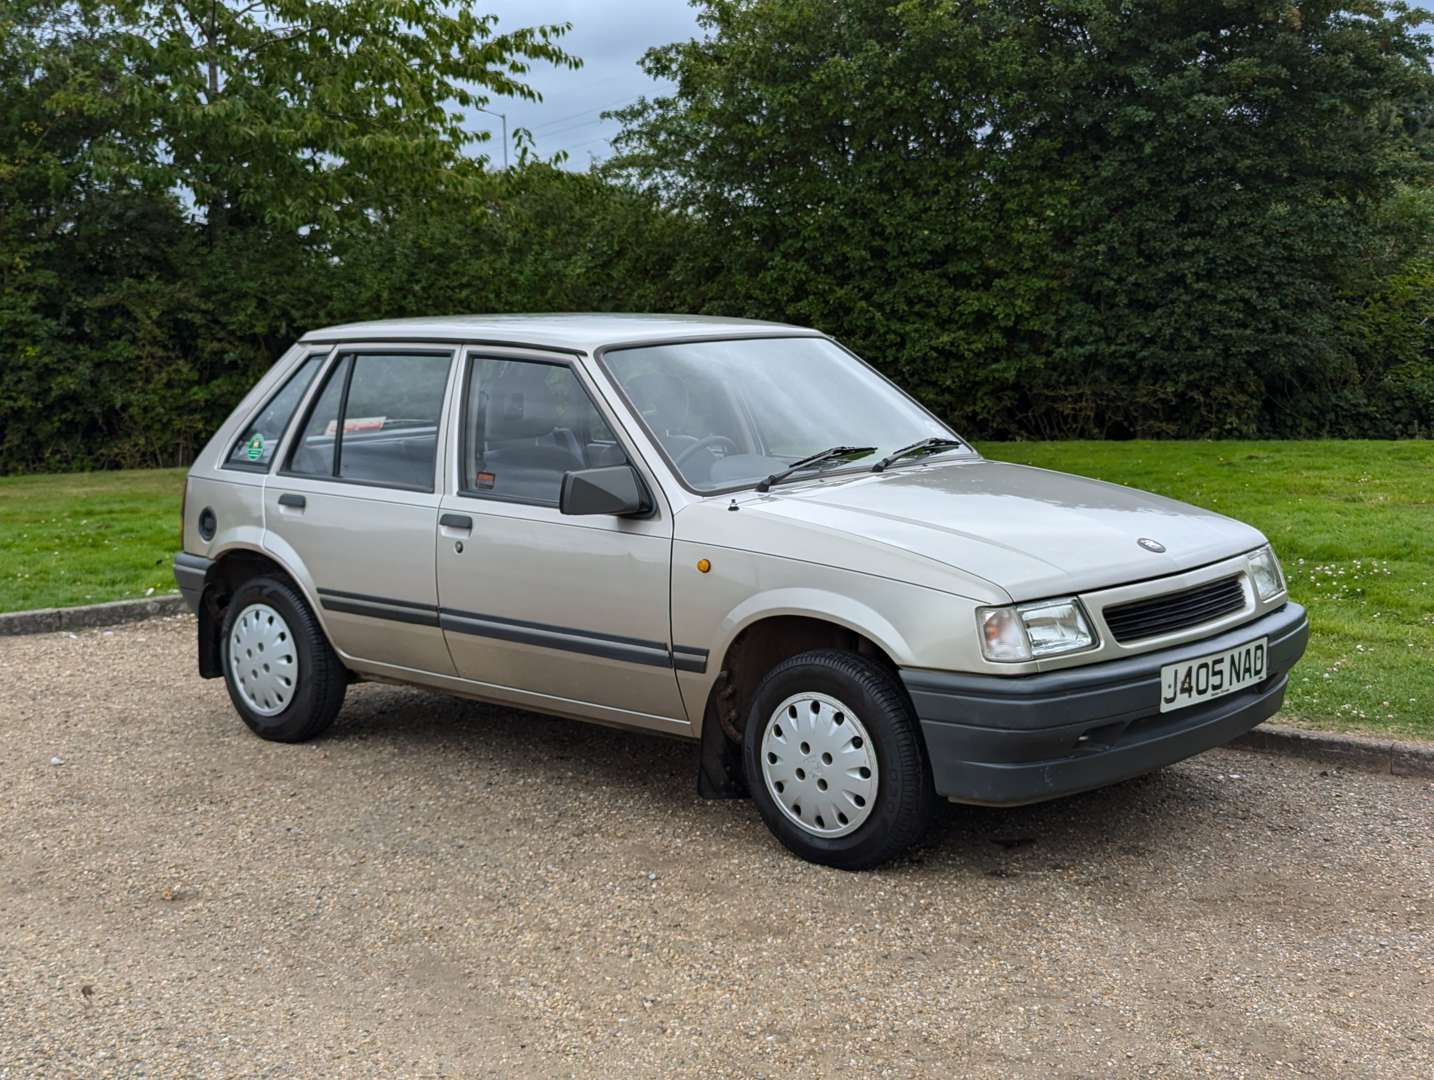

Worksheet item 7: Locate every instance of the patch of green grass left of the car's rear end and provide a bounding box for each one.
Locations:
[0,469,186,611]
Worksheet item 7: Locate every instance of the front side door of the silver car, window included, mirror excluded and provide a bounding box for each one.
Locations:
[437,350,687,727]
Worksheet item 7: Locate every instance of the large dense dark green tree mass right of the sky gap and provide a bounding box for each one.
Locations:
[618,0,1431,436]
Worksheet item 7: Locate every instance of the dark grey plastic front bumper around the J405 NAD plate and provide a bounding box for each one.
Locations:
[901,602,1309,806]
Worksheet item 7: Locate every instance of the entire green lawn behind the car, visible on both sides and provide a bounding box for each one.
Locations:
[0,442,1434,739]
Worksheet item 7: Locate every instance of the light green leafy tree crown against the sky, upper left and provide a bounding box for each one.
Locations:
[81,0,578,242]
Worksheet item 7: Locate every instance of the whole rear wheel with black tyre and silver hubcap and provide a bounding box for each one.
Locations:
[219,577,348,743]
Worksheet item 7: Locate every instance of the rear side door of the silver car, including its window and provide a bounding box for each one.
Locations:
[264,344,453,674]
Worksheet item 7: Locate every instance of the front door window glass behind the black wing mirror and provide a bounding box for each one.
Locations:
[459,357,628,506]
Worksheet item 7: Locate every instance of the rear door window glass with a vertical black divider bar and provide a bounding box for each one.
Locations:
[290,353,452,491]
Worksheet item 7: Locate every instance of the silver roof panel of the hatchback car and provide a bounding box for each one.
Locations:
[301,313,817,353]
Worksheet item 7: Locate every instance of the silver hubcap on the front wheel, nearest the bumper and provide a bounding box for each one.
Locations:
[761,693,879,838]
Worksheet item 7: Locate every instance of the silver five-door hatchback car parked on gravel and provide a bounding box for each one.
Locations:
[175,314,1309,869]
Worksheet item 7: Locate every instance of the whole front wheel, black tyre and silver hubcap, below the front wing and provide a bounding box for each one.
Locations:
[743,650,936,871]
